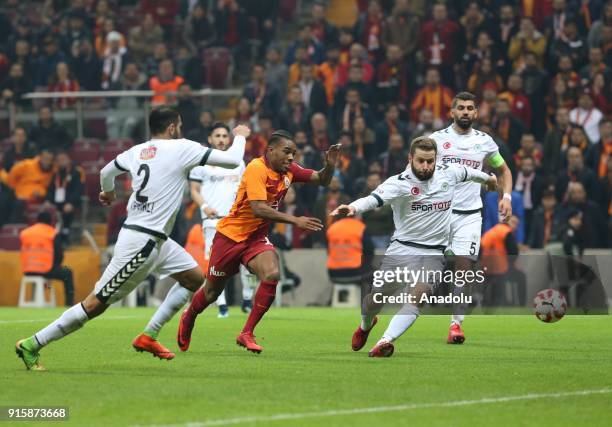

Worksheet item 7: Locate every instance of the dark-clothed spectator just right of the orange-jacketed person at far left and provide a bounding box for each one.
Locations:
[47,151,85,245]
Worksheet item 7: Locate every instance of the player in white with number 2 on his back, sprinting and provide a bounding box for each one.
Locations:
[15,107,250,370]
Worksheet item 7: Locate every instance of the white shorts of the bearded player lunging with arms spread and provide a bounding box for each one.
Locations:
[380,241,444,289]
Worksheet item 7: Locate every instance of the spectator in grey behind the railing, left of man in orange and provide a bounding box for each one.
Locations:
[106,62,147,139]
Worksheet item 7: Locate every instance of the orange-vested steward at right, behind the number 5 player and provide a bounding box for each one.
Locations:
[480,219,526,306]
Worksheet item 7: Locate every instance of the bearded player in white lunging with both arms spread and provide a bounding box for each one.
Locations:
[332,137,497,357]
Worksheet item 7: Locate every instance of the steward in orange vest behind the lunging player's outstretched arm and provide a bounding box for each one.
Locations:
[327,217,374,283]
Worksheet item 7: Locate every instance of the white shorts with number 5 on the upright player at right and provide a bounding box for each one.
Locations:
[446,212,482,259]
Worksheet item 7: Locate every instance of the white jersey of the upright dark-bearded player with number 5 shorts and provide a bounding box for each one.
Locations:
[430,125,499,211]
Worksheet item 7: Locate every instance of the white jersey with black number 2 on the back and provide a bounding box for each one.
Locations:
[115,139,212,235]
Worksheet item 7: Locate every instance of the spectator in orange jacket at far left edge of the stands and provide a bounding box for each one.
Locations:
[7,148,54,203]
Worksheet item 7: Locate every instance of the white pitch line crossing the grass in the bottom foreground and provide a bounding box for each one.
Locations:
[141,388,612,427]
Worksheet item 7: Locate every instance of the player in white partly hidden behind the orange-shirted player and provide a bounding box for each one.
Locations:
[189,123,257,318]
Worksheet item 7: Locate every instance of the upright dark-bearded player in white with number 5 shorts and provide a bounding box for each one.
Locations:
[430,92,512,344]
